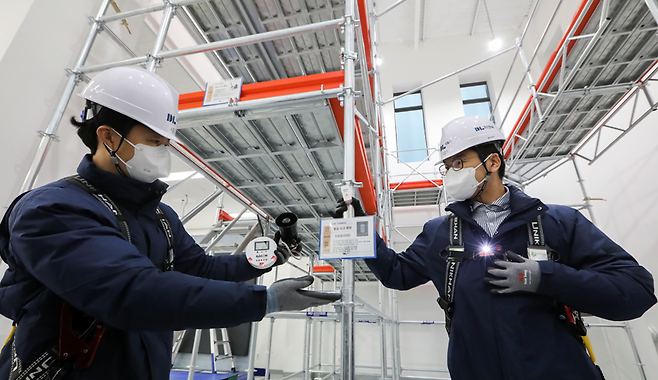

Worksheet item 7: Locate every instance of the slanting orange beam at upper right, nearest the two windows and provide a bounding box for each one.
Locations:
[503,0,601,158]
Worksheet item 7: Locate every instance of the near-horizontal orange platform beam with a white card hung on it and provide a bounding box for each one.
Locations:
[178,71,345,110]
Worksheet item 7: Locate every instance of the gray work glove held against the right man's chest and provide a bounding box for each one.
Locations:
[484,251,541,294]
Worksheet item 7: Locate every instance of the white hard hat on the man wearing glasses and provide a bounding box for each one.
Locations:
[439,116,506,161]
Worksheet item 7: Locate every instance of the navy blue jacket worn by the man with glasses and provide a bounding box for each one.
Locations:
[366,187,656,380]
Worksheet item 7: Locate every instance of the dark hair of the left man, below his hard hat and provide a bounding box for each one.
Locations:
[70,101,140,154]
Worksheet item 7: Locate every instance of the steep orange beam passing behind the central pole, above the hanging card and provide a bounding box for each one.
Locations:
[329,99,377,215]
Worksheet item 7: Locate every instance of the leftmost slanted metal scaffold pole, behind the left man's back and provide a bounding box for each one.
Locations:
[21,0,110,193]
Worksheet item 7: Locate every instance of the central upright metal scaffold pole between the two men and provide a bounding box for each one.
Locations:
[341,0,356,380]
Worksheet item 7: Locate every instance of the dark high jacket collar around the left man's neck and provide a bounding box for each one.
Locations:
[78,154,168,209]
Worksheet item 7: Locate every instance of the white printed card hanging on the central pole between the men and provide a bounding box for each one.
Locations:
[320,215,377,260]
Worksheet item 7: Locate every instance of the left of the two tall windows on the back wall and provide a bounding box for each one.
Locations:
[394,92,427,162]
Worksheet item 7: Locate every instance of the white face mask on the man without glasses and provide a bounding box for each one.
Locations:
[107,131,171,183]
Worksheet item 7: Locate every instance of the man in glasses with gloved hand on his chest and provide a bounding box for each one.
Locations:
[336,117,656,380]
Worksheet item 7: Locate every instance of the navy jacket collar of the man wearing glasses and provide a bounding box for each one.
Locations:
[446,185,548,233]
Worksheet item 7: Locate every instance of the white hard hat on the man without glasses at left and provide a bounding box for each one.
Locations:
[80,67,178,142]
